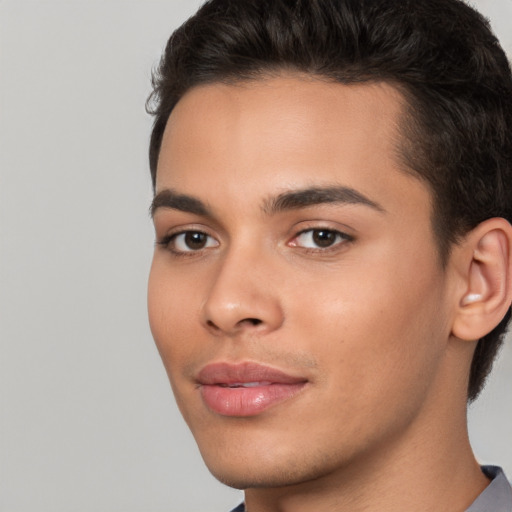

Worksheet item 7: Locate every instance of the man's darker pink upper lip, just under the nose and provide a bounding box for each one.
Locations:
[197,362,307,385]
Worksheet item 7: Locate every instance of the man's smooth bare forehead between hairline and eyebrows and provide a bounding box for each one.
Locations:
[156,75,423,218]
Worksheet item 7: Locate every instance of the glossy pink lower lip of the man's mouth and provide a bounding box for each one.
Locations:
[201,382,306,417]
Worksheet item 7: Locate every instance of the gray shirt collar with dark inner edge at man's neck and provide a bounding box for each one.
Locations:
[231,466,512,512]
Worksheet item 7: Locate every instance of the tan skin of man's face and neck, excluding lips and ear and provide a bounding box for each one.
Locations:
[149,75,488,512]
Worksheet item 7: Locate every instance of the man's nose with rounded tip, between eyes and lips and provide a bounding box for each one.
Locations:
[202,247,284,336]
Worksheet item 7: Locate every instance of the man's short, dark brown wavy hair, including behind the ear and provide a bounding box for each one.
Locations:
[147,0,512,400]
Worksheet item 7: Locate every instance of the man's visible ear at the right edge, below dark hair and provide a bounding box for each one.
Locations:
[452,218,512,340]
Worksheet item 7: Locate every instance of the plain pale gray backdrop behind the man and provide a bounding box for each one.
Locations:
[0,0,512,512]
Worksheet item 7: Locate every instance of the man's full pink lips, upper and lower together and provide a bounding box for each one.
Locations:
[197,362,308,417]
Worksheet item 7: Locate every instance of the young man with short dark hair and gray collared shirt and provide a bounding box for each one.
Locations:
[145,0,512,512]
